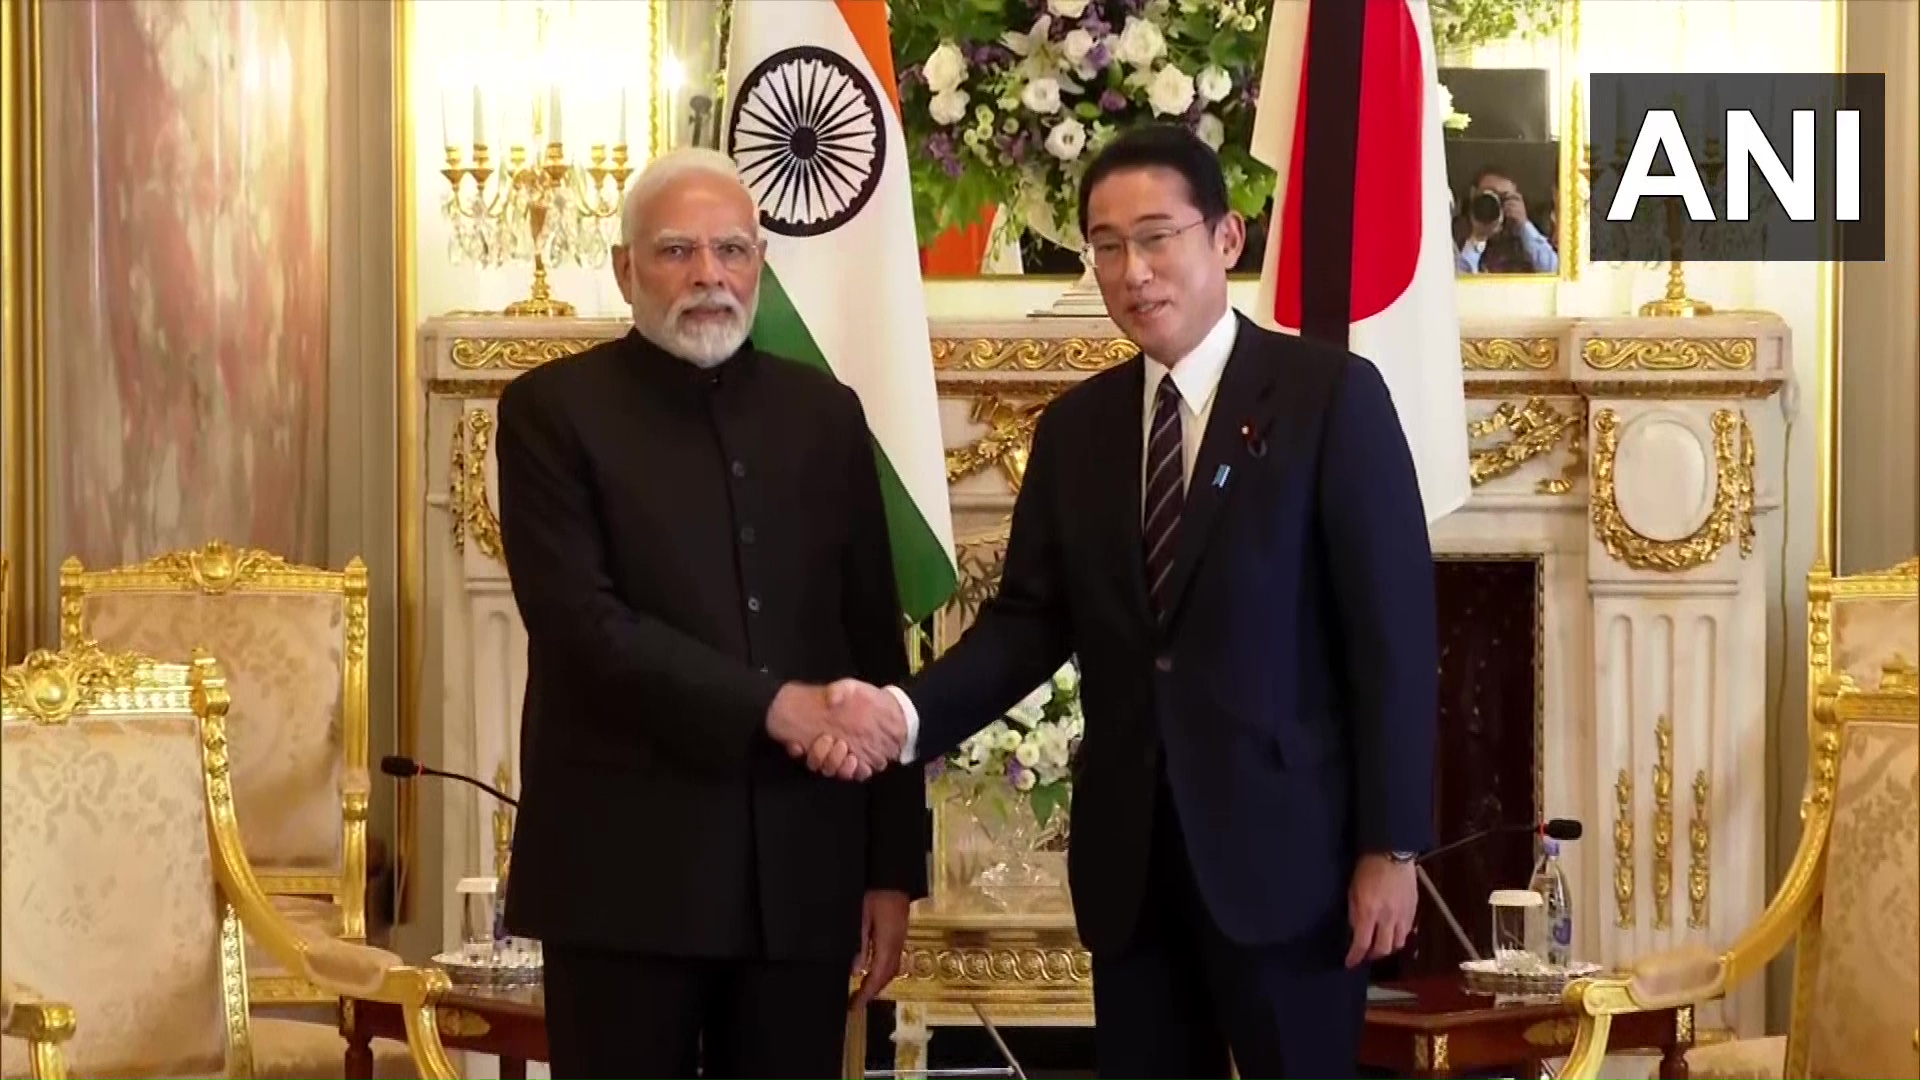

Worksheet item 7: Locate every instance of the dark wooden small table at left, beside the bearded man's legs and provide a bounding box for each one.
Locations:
[340,986,547,1080]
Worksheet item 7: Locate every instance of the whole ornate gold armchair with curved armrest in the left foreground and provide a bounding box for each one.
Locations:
[0,642,455,1080]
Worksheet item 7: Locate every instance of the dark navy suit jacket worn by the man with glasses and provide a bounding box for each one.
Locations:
[910,317,1438,951]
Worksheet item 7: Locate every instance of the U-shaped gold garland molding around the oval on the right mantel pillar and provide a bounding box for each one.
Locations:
[1592,409,1753,573]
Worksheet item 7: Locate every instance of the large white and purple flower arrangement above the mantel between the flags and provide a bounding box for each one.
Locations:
[889,0,1273,250]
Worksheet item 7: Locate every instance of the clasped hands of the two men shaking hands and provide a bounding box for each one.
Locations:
[766,678,906,780]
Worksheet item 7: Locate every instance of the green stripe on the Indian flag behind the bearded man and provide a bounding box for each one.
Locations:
[753,267,956,623]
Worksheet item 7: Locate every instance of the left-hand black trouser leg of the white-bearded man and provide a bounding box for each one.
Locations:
[543,945,712,1080]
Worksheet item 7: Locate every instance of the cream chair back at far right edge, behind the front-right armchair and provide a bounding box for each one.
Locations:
[1807,557,1920,690]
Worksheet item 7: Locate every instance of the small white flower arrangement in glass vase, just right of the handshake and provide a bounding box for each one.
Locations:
[941,661,1087,828]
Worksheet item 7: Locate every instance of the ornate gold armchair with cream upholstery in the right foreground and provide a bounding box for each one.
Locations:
[1561,661,1920,1080]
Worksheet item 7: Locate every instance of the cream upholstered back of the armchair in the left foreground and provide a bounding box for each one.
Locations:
[0,646,248,1078]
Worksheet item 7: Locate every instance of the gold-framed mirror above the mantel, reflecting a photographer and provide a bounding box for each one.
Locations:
[889,0,1580,281]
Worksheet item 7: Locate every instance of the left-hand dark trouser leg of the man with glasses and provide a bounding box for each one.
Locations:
[1092,772,1229,1080]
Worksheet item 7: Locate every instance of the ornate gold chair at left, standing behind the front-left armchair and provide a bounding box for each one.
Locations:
[60,540,369,1005]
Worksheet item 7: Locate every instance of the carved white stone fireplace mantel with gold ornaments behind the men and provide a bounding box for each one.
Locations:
[420,313,1791,1034]
